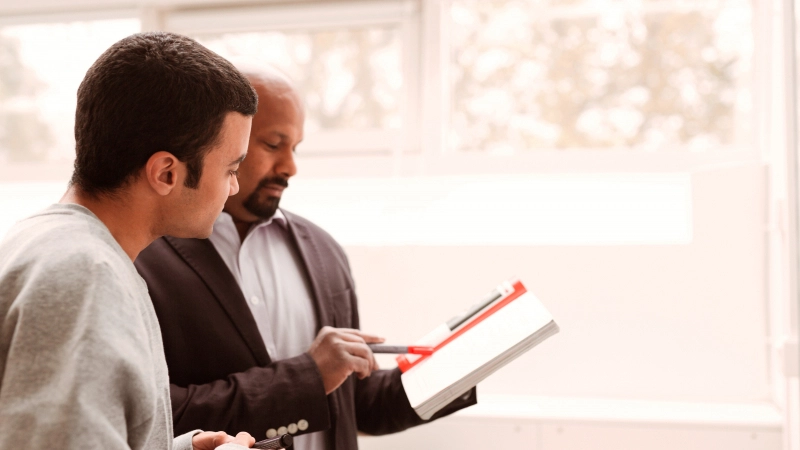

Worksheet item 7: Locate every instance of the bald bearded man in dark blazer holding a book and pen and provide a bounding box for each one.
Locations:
[136,68,476,450]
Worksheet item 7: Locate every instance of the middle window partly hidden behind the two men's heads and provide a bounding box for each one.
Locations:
[166,0,418,157]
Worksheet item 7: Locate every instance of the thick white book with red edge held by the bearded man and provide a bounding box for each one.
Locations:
[398,280,558,419]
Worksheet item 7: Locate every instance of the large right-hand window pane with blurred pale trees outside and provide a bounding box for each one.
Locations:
[449,0,753,153]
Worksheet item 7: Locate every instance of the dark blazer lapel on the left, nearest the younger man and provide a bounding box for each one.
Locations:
[165,236,271,366]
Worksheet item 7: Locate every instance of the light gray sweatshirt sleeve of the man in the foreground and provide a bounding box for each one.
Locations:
[0,256,159,450]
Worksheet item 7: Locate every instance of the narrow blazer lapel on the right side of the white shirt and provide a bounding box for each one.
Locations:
[282,213,333,328]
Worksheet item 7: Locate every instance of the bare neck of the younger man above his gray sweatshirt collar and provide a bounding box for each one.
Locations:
[59,186,158,261]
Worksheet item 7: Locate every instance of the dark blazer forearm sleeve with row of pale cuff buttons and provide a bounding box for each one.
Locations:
[170,354,331,438]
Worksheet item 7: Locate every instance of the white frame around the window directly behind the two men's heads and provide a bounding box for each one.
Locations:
[163,0,419,158]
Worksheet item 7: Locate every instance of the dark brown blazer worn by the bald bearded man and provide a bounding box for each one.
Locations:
[136,211,476,450]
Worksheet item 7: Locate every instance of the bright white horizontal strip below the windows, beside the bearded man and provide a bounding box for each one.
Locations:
[282,173,692,246]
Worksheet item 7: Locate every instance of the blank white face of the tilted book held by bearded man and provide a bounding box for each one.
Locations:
[402,292,553,408]
